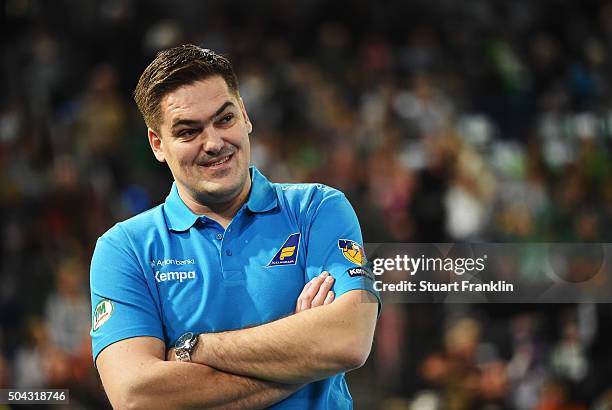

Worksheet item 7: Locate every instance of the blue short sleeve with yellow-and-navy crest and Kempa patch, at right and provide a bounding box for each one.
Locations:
[306,188,380,305]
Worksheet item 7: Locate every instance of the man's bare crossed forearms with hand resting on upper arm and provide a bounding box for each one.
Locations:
[96,274,378,409]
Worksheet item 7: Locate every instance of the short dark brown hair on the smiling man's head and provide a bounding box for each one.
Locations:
[134,44,238,131]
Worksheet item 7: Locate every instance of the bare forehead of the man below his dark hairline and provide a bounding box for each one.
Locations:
[160,76,238,126]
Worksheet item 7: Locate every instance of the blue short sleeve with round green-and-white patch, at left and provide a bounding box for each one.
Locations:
[90,225,164,363]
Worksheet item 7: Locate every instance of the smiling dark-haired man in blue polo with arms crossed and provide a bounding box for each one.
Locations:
[91,45,378,409]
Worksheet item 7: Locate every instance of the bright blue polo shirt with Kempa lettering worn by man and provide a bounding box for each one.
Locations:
[90,167,378,409]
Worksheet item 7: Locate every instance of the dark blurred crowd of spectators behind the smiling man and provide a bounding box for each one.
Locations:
[0,0,612,410]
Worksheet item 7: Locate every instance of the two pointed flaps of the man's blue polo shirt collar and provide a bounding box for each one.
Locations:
[164,166,278,232]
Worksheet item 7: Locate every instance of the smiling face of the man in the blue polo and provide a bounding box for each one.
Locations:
[149,76,252,206]
